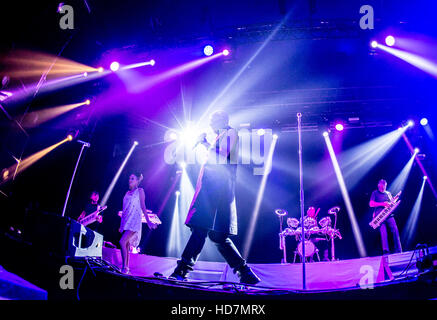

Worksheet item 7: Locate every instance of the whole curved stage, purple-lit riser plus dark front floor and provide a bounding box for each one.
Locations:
[1,230,437,301]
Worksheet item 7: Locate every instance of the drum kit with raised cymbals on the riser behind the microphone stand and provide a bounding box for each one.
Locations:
[275,207,342,263]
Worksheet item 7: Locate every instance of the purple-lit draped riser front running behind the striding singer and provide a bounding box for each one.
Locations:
[99,247,437,291]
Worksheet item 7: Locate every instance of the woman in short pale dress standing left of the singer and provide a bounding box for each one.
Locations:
[119,174,157,274]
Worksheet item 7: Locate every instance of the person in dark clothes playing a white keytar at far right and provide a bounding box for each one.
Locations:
[369,179,402,254]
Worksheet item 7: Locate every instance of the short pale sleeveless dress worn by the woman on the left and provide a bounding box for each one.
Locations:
[120,188,143,247]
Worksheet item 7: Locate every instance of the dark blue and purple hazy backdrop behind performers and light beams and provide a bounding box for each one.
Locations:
[0,0,437,263]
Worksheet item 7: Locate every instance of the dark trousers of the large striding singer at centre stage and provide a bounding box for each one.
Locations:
[177,227,246,271]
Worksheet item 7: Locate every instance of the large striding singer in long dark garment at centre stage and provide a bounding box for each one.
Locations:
[170,111,260,284]
